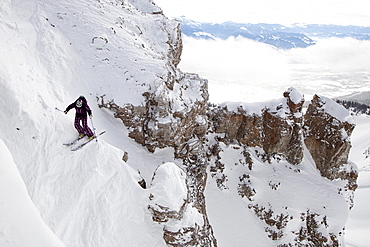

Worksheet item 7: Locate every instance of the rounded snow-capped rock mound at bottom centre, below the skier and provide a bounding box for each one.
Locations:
[149,163,204,246]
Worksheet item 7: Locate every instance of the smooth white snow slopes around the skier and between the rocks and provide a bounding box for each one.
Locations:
[0,0,370,247]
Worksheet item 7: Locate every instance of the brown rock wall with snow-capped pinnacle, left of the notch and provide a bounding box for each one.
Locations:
[208,88,304,164]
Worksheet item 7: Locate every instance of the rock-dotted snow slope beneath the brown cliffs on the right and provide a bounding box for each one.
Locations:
[206,144,348,247]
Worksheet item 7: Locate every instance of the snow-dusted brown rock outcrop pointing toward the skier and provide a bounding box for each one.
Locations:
[99,72,208,152]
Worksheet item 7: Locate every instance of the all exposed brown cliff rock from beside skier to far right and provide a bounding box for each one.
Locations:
[101,79,357,246]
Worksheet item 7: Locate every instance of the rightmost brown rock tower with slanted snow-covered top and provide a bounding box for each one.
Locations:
[303,95,358,208]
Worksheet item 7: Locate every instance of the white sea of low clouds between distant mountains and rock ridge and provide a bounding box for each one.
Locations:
[179,37,370,102]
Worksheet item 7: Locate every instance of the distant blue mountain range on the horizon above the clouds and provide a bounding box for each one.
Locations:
[181,19,370,49]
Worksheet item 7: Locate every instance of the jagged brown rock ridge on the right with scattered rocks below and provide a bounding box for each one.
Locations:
[208,89,357,246]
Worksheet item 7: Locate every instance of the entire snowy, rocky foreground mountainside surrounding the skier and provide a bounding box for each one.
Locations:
[0,0,364,247]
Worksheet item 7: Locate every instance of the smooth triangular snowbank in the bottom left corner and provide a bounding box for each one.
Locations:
[0,140,64,247]
